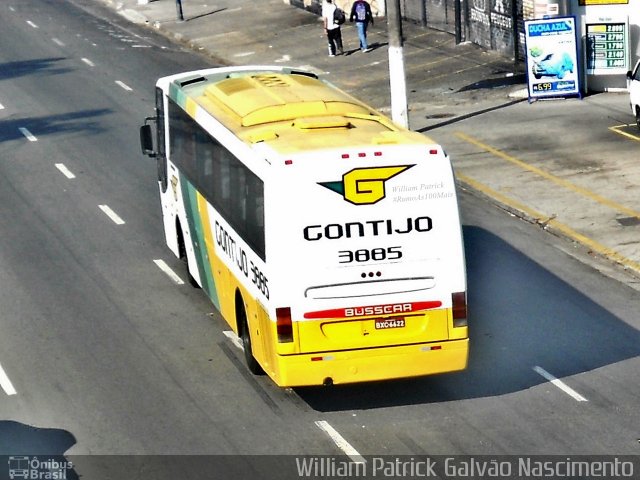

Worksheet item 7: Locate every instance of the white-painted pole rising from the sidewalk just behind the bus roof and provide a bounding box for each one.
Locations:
[387,0,409,128]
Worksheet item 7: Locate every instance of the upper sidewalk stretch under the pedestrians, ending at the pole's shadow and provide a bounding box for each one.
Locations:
[104,0,524,130]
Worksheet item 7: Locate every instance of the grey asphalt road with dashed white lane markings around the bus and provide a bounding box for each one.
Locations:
[0,0,640,473]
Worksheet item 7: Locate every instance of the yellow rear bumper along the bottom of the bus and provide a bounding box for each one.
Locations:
[274,338,469,387]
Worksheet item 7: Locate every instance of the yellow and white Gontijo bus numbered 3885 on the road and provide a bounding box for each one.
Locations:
[141,66,469,386]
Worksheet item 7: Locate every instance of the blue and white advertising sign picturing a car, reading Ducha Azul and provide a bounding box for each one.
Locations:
[525,17,582,101]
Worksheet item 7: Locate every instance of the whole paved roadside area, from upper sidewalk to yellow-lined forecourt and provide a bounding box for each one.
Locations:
[96,0,640,288]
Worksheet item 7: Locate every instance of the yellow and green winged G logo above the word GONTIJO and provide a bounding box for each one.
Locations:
[318,165,413,205]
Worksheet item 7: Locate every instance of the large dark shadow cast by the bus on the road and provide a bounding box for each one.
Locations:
[296,227,640,411]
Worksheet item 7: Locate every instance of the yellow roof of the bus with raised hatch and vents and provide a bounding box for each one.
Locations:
[165,67,434,154]
